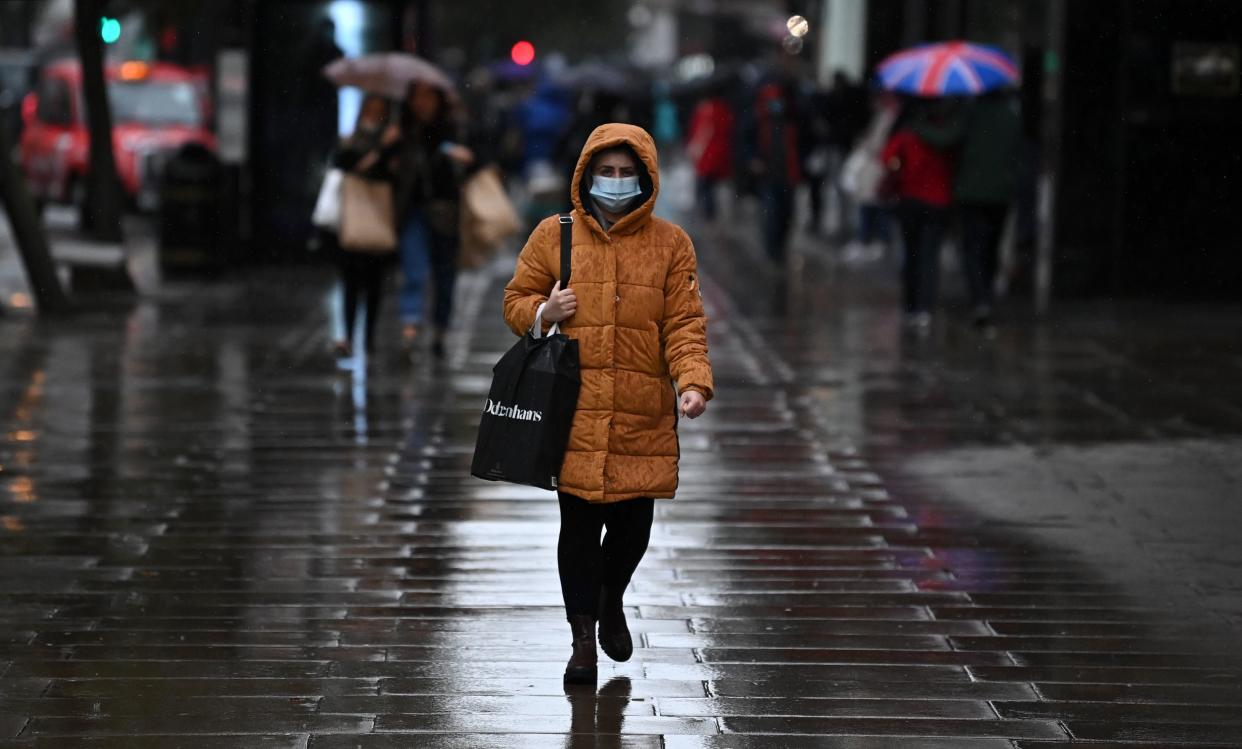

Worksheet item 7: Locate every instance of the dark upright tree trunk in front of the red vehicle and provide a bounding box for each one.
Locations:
[73,0,123,242]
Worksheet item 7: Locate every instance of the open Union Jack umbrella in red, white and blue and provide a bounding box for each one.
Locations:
[876,41,1018,97]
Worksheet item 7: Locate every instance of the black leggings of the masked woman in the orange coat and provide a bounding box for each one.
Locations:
[556,494,656,616]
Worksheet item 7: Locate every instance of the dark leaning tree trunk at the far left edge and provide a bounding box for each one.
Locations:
[0,123,70,314]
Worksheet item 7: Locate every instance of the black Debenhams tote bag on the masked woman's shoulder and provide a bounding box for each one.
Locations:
[471,215,581,489]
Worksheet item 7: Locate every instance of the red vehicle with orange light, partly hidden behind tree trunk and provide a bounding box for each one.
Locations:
[20,60,216,210]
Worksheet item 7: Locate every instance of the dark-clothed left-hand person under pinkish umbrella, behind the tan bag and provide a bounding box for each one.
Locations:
[333,94,401,358]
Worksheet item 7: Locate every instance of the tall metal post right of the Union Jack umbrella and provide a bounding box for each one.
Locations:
[1035,0,1067,315]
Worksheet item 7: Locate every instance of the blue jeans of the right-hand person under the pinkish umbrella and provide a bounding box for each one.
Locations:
[397,210,457,329]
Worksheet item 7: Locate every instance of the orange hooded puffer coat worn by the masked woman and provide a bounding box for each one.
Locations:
[504,124,713,502]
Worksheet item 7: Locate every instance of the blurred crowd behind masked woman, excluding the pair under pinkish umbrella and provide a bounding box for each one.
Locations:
[452,67,1030,330]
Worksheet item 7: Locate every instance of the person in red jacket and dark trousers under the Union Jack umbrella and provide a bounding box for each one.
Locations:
[881,102,953,332]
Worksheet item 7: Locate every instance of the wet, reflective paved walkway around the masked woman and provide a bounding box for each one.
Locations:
[0,202,1242,749]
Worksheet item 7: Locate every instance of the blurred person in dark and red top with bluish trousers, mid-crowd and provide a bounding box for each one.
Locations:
[750,81,801,265]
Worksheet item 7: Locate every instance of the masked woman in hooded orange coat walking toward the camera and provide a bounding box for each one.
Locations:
[504,123,713,683]
